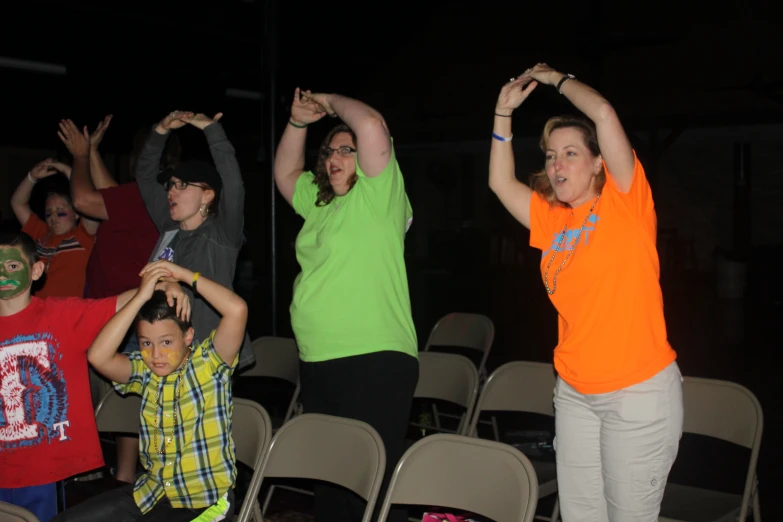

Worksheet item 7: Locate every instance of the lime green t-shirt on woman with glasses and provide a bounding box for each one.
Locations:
[291,144,418,362]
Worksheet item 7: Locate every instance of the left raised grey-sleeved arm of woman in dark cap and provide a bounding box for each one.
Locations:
[136,111,193,232]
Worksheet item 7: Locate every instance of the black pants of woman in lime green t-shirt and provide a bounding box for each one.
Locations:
[300,351,419,522]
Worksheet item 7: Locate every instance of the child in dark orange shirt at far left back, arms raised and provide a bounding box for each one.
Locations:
[11,148,98,297]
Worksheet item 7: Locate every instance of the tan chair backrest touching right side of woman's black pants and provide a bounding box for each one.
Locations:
[413,352,478,419]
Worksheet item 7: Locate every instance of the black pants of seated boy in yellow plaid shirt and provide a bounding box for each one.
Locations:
[51,484,234,522]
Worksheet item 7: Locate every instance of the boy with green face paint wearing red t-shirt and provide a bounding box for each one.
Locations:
[0,232,190,521]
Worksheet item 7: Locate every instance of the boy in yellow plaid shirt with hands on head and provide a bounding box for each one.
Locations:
[54,261,247,522]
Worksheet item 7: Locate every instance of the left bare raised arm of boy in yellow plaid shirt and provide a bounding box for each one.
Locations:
[87,267,175,384]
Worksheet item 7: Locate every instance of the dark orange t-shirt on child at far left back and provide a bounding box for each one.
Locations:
[22,213,95,298]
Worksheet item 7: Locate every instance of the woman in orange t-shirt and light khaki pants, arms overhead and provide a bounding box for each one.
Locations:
[489,64,683,522]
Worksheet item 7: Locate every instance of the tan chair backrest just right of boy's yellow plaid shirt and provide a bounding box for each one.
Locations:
[231,397,272,470]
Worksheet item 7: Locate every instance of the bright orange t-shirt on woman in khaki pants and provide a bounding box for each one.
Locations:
[530,153,677,394]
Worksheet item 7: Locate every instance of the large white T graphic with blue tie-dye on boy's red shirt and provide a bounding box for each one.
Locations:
[0,334,70,451]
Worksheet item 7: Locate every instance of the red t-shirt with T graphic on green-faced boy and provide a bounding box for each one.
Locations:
[0,297,117,488]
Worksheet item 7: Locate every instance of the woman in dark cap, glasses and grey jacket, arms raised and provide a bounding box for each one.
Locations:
[136,111,255,369]
